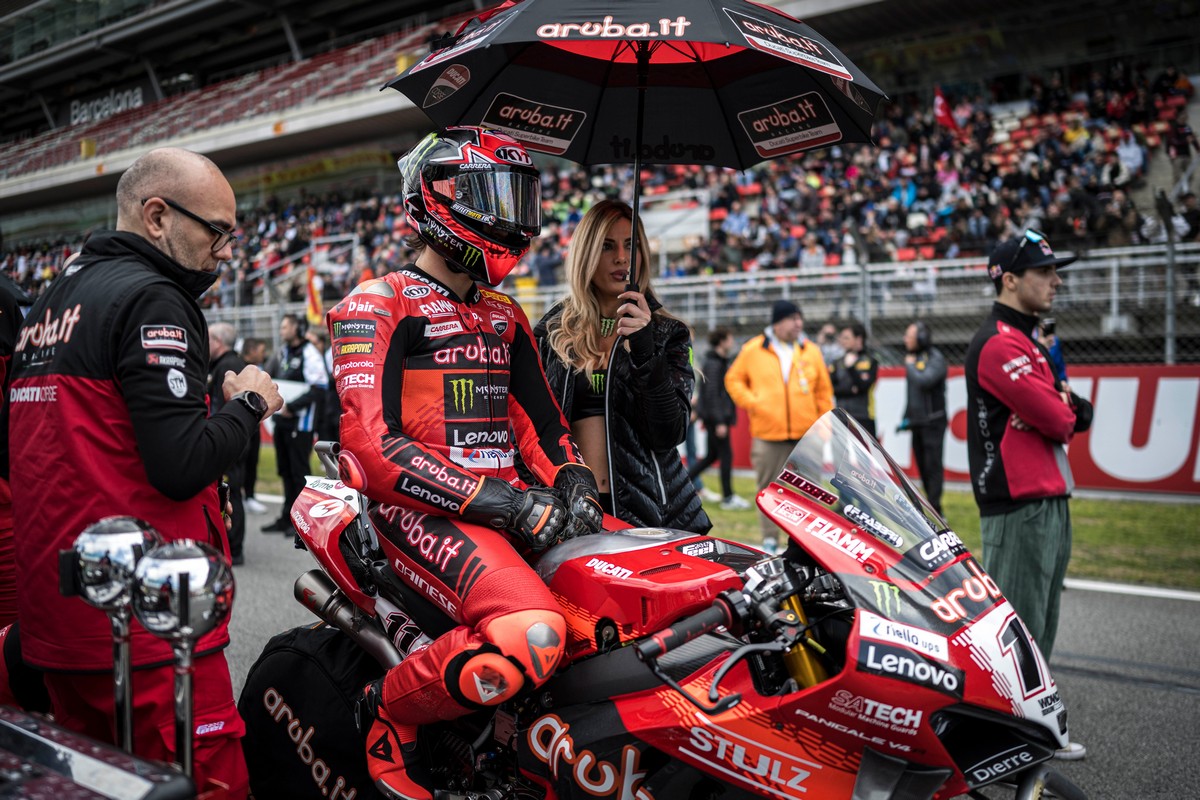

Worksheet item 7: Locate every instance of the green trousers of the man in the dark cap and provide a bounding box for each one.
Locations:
[980,498,1070,661]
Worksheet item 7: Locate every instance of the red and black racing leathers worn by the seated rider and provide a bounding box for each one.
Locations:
[328,265,582,724]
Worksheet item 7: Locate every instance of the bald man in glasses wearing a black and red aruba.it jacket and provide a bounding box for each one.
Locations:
[0,149,283,798]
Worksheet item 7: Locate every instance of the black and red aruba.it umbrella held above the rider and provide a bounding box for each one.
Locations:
[388,0,883,283]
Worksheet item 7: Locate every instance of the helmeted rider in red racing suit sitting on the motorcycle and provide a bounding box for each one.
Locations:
[328,127,602,799]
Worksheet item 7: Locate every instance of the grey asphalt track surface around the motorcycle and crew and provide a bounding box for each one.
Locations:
[227,503,1200,800]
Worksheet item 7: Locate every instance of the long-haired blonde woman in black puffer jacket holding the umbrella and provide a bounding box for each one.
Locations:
[534,200,712,533]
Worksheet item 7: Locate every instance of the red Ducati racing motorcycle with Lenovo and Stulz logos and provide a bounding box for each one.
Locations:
[262,409,1086,800]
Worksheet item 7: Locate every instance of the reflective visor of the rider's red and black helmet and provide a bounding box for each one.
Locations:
[430,164,541,229]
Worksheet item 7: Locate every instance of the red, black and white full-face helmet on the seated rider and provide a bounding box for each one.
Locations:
[397,126,541,285]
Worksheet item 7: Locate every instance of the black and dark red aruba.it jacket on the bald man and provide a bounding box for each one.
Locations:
[0,231,257,670]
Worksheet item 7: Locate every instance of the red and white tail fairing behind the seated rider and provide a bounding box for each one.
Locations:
[292,475,374,614]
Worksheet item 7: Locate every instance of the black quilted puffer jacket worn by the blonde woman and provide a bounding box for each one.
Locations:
[534,303,713,534]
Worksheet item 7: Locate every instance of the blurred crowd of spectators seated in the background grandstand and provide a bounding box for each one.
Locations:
[0,61,1200,306]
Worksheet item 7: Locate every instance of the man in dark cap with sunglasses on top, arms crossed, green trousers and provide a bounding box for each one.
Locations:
[966,230,1092,759]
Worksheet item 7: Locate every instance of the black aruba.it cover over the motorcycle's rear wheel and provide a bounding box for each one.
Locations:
[238,624,384,800]
